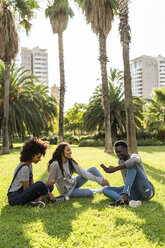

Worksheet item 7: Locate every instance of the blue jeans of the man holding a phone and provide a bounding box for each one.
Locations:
[103,166,152,201]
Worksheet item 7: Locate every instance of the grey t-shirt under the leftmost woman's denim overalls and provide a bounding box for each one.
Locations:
[9,164,33,192]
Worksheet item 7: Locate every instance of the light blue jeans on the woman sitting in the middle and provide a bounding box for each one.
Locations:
[69,167,103,198]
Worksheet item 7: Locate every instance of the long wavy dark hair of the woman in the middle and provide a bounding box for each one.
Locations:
[48,142,77,176]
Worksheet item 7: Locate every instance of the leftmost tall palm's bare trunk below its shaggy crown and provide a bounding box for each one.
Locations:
[2,62,10,154]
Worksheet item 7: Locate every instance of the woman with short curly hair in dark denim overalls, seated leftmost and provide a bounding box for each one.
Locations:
[7,138,55,207]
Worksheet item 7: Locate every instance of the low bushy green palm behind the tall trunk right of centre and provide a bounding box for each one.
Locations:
[84,81,125,138]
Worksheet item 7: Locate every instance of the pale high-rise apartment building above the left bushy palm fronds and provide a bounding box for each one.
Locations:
[21,47,48,86]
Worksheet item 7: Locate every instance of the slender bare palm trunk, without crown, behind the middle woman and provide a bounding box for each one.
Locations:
[58,33,65,142]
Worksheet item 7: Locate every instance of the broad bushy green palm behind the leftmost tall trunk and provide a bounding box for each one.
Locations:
[0,62,57,146]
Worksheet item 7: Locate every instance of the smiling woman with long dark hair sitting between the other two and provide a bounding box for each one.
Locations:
[48,143,109,201]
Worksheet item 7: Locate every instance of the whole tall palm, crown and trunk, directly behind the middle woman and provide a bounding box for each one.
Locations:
[45,0,74,142]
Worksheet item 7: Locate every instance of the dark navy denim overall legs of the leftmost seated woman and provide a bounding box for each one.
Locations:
[8,181,48,206]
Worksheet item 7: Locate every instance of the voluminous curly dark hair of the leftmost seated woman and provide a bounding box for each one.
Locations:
[20,137,49,162]
